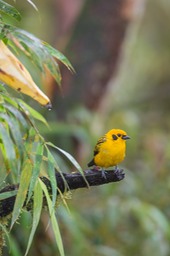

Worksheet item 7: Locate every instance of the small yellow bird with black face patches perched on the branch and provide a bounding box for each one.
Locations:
[88,129,130,172]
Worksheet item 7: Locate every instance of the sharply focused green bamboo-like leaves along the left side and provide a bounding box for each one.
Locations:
[0,1,78,255]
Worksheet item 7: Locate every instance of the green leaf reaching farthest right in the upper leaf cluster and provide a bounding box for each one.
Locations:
[43,42,75,72]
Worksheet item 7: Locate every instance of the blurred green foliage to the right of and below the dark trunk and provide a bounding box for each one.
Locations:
[1,0,170,256]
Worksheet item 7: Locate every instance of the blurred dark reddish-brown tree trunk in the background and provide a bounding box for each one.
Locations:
[50,0,132,117]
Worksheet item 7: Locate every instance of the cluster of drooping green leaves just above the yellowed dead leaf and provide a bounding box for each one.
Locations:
[0,22,74,91]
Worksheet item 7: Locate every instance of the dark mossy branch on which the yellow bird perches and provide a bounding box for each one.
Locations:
[0,170,125,218]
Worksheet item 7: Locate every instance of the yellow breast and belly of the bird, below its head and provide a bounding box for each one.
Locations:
[94,139,126,168]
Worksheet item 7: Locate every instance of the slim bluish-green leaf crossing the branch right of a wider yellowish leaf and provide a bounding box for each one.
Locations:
[27,143,44,202]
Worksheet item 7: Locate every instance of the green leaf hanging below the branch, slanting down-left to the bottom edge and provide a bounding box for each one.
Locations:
[25,180,43,256]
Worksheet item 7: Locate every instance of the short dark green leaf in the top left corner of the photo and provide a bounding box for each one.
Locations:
[0,0,21,21]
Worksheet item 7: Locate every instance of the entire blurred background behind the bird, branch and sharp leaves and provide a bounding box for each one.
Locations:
[3,0,170,256]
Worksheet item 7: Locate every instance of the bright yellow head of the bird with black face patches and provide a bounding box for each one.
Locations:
[106,129,130,142]
